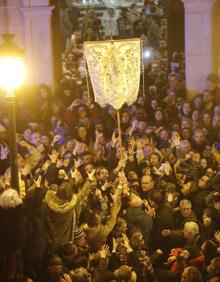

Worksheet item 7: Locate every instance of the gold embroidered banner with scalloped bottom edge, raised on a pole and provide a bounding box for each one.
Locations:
[84,39,141,110]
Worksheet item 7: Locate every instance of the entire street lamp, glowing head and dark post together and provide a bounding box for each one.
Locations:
[0,34,24,190]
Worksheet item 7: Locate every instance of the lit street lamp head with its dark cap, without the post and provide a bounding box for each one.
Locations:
[0,34,25,97]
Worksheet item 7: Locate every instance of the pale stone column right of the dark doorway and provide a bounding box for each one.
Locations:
[182,0,214,91]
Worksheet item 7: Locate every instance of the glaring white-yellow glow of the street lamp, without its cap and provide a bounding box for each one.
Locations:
[0,57,25,92]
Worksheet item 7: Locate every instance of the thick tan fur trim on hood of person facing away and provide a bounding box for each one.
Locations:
[45,190,78,214]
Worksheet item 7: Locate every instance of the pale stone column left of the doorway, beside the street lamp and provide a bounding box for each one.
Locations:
[21,0,54,85]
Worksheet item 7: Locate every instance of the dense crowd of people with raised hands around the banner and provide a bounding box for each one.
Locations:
[0,1,220,282]
